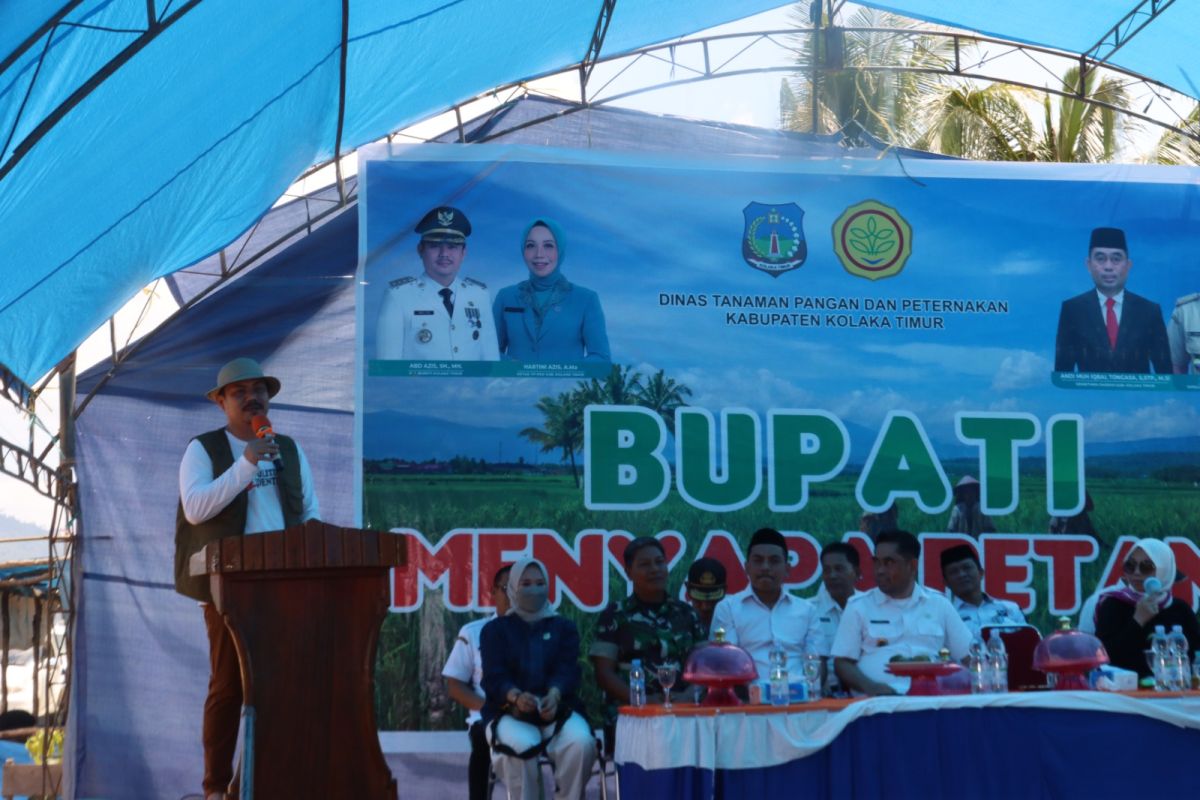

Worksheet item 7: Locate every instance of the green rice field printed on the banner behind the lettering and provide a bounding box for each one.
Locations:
[364,464,1200,729]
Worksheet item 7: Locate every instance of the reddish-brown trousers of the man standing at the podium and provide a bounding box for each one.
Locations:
[202,603,241,794]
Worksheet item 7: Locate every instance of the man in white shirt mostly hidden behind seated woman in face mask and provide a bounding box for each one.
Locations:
[442,564,512,800]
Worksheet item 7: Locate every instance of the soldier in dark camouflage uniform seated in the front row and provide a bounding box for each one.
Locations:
[588,536,707,726]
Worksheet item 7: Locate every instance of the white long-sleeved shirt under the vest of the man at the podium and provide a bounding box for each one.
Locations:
[179,431,320,534]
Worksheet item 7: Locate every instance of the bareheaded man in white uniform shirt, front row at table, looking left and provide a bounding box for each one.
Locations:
[832,530,971,696]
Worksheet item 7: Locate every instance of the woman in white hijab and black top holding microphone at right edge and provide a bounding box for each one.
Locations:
[1096,539,1200,678]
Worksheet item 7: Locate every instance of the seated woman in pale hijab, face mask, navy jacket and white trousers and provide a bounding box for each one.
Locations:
[480,559,596,800]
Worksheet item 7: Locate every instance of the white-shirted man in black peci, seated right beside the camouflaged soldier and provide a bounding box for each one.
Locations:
[709,528,816,680]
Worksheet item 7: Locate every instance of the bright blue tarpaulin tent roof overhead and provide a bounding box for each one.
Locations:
[0,0,1200,384]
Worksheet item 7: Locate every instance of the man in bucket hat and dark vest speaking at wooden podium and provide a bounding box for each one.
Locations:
[175,359,319,800]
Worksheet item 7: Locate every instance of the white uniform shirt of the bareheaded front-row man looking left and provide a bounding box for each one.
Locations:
[832,585,972,693]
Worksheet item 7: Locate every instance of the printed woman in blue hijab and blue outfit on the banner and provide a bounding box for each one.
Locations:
[492,217,610,361]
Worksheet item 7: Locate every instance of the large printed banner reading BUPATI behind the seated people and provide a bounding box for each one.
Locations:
[359,145,1200,724]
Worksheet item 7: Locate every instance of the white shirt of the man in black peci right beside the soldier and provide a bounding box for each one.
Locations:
[709,588,816,680]
